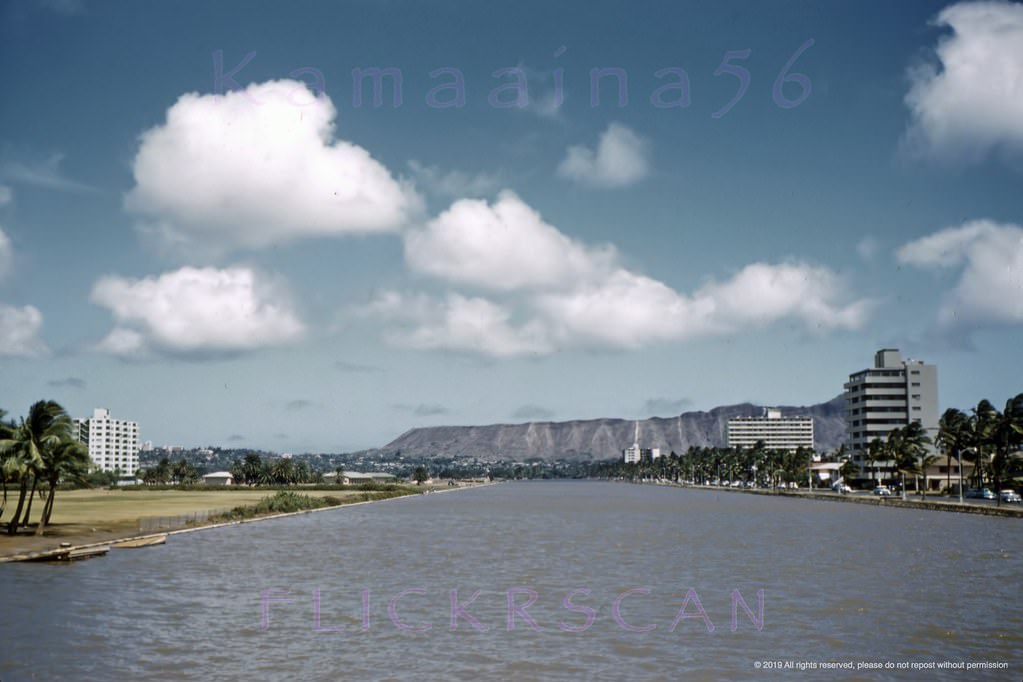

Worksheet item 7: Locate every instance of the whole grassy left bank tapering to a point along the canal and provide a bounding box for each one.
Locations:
[0,484,487,563]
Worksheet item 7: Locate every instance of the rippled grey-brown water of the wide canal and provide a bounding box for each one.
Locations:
[0,482,1023,682]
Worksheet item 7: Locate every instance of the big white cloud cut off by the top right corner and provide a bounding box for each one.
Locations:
[905,2,1023,162]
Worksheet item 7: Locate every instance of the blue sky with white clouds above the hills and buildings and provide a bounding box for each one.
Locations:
[0,0,1023,453]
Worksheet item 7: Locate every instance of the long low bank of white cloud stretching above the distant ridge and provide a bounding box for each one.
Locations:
[364,257,873,357]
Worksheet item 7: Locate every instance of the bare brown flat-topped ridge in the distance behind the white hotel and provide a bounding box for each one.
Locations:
[377,397,846,460]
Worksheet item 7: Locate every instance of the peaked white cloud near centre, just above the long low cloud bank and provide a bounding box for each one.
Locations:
[405,191,615,291]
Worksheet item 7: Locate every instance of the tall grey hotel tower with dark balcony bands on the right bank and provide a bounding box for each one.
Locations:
[845,348,938,472]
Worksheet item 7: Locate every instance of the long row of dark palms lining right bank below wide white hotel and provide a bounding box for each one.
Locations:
[590,442,818,487]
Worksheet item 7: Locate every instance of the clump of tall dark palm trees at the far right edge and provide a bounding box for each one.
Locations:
[936,393,1023,501]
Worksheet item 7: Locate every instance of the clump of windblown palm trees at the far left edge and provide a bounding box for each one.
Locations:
[0,400,91,535]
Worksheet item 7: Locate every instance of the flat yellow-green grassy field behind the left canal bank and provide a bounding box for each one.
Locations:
[15,488,384,526]
